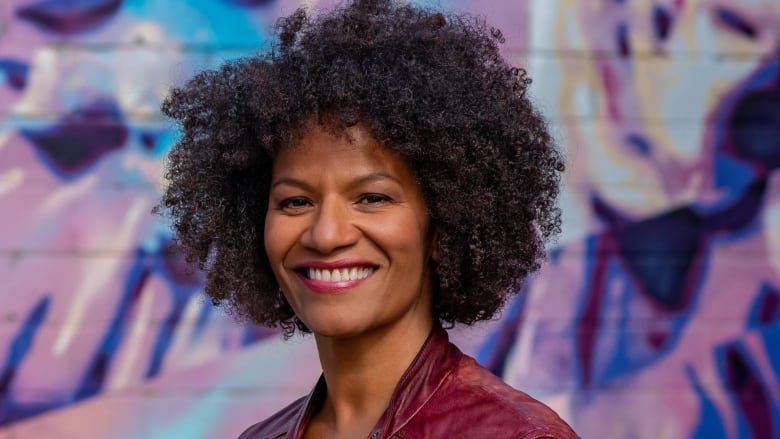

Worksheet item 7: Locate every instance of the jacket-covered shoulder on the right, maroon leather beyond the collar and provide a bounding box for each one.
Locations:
[406,355,578,439]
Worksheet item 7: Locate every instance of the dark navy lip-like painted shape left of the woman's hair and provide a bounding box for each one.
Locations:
[21,99,128,179]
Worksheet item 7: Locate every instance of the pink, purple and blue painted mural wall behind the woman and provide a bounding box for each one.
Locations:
[0,0,780,439]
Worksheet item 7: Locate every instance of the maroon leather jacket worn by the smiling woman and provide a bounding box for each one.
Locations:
[239,326,578,439]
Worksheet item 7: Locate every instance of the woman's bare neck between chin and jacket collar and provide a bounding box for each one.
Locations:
[315,319,433,431]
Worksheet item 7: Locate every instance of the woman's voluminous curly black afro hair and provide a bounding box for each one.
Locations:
[157,0,564,335]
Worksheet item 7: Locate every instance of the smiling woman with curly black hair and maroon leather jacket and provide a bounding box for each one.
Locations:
[157,0,576,438]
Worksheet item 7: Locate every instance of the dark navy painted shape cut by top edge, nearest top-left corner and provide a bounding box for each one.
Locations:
[16,0,122,35]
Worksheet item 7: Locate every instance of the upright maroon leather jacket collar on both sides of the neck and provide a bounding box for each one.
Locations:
[285,323,463,439]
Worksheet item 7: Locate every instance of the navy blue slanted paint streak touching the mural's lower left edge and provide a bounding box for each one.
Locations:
[0,296,51,426]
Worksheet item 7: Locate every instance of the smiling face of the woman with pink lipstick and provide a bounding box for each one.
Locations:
[265,125,433,338]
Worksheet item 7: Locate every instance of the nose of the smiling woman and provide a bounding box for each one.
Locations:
[301,199,360,254]
